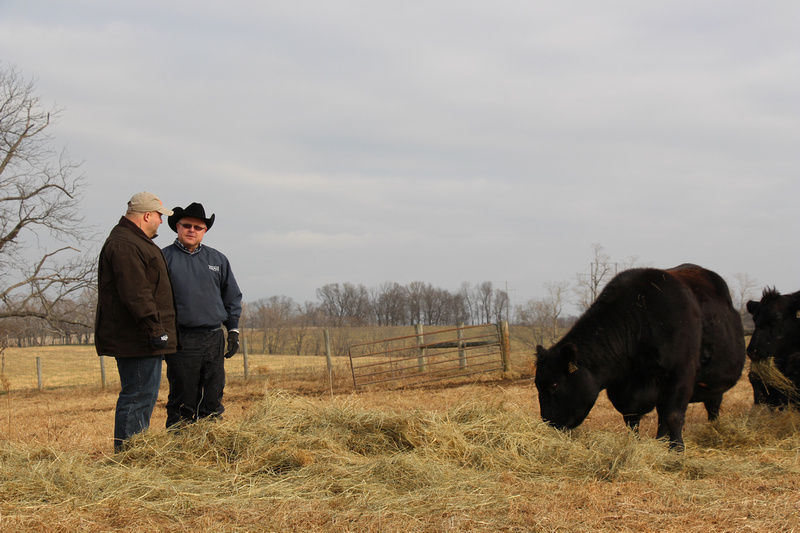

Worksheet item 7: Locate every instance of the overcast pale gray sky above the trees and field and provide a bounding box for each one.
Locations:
[0,0,800,314]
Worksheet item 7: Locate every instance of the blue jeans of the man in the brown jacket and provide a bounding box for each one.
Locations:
[114,355,163,452]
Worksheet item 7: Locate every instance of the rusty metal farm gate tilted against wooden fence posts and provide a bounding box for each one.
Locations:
[348,322,510,390]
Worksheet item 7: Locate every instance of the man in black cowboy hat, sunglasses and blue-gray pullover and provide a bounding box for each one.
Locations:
[162,202,242,428]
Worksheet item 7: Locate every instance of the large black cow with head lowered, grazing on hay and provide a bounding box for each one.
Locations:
[536,265,745,450]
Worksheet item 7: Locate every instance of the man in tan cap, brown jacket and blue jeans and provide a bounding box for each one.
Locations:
[95,192,178,452]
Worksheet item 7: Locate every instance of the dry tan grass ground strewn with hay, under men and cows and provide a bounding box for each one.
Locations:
[0,342,800,533]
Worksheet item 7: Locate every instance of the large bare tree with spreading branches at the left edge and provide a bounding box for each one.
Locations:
[0,66,95,327]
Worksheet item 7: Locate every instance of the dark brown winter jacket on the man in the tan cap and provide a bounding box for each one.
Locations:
[94,217,178,357]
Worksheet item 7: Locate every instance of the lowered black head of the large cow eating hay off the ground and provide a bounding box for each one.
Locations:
[536,343,600,429]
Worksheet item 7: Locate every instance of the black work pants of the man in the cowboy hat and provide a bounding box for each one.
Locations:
[166,328,225,428]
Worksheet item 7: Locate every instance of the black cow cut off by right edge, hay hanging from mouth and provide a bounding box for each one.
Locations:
[747,288,800,407]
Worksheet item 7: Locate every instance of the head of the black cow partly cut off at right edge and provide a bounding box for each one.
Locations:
[747,288,800,361]
